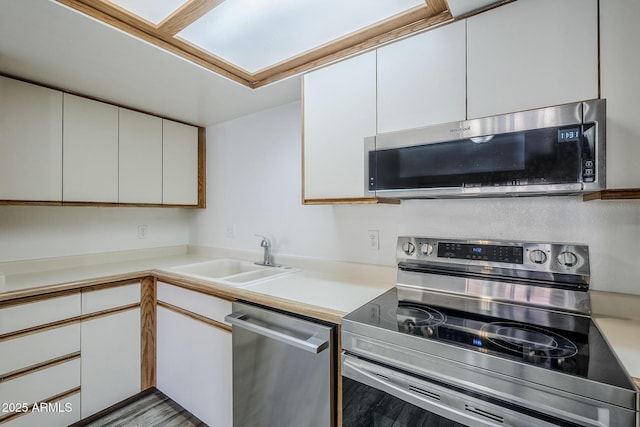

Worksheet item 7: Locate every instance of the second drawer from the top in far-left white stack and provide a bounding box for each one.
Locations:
[0,323,80,376]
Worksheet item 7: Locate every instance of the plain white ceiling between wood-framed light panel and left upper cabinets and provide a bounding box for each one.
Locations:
[0,0,301,126]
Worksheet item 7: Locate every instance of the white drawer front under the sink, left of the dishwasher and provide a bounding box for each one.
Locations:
[158,282,231,325]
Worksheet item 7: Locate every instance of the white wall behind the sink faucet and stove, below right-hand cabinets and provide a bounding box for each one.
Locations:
[190,102,640,294]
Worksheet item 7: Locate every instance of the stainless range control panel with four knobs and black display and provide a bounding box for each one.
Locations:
[396,236,589,275]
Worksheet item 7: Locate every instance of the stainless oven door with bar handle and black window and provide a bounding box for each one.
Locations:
[342,353,575,427]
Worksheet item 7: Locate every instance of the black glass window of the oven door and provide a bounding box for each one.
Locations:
[342,377,467,427]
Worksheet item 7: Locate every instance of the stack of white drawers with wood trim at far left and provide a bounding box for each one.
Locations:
[0,294,80,427]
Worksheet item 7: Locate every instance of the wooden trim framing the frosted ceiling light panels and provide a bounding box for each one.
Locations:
[56,0,453,88]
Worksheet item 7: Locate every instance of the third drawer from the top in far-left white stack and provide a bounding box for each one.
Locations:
[0,358,80,410]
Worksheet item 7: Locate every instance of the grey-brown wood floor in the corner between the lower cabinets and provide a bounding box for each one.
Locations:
[70,388,207,427]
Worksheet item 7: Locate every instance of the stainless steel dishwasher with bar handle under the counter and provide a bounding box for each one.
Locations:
[225,302,336,427]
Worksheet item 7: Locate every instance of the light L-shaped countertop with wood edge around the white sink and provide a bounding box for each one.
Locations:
[0,248,394,323]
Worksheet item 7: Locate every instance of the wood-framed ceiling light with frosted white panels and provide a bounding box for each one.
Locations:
[54,0,452,88]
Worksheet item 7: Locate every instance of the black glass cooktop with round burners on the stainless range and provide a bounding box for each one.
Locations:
[343,289,633,389]
